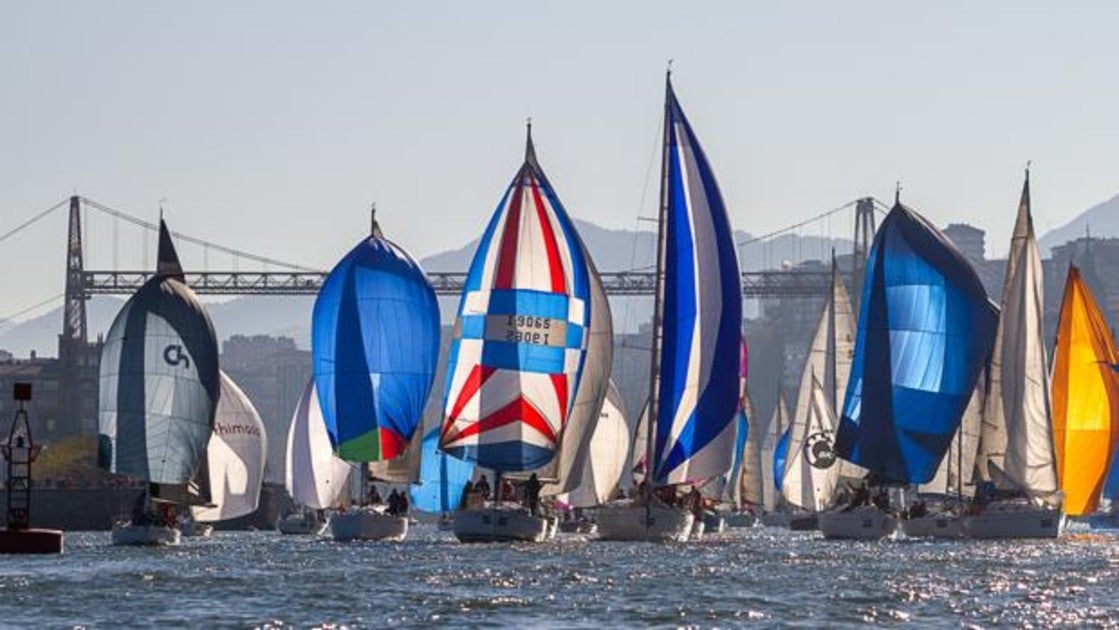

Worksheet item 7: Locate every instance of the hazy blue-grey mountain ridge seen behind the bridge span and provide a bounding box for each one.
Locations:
[0,222,852,357]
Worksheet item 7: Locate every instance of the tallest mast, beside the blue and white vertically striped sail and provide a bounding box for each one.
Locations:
[645,62,673,516]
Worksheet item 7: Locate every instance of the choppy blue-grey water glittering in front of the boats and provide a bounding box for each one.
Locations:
[0,525,1119,628]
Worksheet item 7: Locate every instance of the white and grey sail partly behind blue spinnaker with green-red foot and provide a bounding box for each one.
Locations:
[284,379,350,509]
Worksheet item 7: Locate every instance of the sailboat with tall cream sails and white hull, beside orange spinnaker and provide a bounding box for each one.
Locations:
[963,170,1062,538]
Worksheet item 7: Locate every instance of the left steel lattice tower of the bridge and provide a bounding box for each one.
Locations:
[56,195,101,435]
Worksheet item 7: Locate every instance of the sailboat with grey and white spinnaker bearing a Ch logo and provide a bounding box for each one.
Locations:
[97,218,220,545]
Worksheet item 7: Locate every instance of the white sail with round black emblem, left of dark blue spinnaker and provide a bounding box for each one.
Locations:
[781,374,839,511]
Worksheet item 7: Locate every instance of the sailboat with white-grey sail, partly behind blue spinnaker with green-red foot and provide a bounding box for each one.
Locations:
[276,378,352,536]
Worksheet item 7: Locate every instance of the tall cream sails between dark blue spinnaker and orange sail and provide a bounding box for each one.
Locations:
[980,172,1060,505]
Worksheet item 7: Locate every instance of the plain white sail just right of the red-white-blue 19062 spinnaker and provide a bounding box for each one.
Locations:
[556,383,632,508]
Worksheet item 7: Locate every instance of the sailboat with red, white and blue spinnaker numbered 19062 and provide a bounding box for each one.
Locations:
[440,125,609,543]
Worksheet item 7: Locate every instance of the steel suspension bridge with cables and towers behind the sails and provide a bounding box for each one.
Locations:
[0,195,886,436]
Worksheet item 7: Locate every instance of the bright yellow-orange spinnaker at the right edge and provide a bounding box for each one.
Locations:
[1051,266,1119,516]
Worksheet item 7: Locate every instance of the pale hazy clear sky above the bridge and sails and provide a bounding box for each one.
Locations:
[0,0,1119,317]
